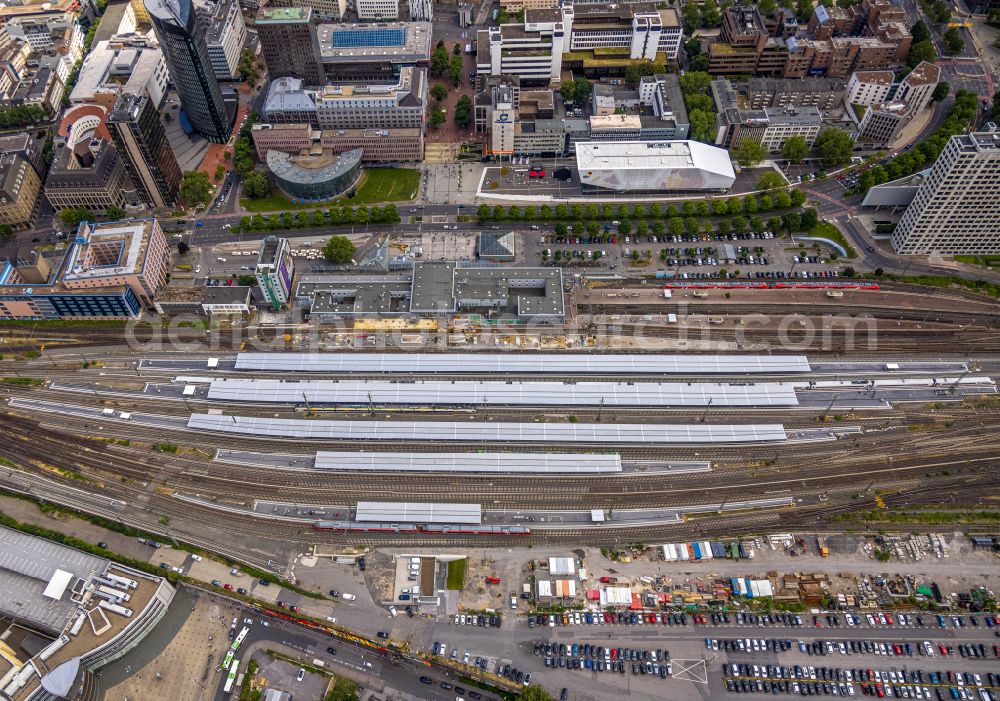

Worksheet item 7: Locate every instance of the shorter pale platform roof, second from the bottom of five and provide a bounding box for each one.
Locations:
[315,450,622,474]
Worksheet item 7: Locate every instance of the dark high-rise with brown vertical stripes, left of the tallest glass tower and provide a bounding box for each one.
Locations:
[107,95,181,207]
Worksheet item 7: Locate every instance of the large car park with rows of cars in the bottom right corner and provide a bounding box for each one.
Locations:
[500,611,1000,701]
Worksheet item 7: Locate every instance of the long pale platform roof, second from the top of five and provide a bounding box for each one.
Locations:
[208,379,798,407]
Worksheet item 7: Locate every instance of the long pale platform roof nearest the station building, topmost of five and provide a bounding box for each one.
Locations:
[230,353,810,375]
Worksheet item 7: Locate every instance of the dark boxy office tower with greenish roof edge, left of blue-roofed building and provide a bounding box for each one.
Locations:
[257,7,326,86]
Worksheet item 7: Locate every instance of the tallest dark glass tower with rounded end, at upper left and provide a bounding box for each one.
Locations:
[145,0,233,144]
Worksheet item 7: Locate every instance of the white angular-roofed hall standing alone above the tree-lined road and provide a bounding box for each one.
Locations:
[576,141,736,192]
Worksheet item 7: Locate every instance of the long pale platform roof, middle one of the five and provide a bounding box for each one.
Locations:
[188,414,786,444]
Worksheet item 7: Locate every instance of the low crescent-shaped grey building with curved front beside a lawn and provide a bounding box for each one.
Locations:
[267,148,362,200]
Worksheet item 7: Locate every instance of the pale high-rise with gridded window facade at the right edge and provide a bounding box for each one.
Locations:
[892,125,1000,255]
